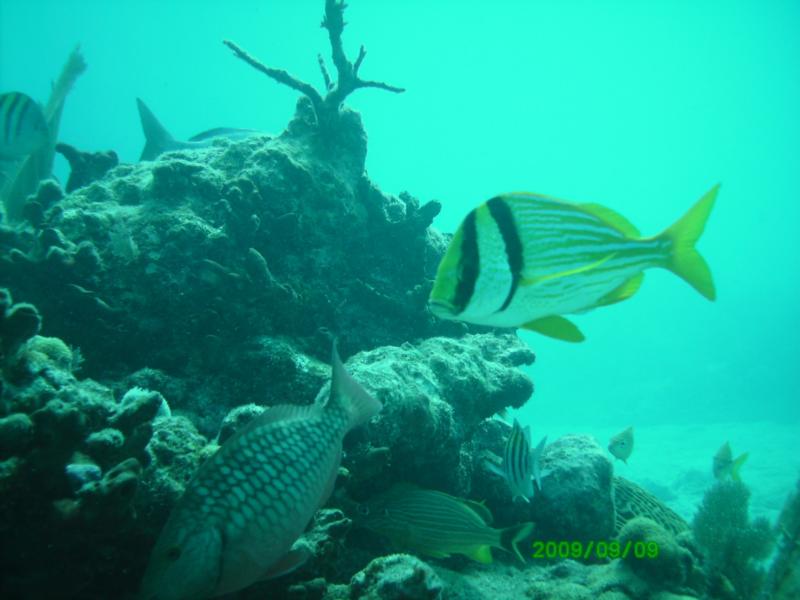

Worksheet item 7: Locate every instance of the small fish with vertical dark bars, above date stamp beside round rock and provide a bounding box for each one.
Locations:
[486,419,547,502]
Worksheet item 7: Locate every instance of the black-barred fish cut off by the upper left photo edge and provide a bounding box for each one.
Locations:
[0,92,48,161]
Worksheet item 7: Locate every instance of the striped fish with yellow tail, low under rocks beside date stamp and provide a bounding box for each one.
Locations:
[355,484,533,563]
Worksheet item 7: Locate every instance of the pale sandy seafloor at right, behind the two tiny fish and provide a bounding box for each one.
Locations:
[531,421,800,523]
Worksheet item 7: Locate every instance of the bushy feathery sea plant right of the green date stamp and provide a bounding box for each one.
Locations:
[692,479,775,600]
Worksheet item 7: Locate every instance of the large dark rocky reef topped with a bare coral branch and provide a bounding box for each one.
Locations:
[0,0,797,600]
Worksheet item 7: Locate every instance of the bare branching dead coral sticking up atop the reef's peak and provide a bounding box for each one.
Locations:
[223,0,405,128]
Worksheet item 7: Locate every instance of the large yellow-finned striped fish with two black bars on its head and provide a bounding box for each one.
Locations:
[429,185,719,342]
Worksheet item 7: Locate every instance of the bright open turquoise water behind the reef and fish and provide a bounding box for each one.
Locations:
[0,0,800,568]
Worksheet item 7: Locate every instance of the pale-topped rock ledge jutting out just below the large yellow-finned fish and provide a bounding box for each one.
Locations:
[340,334,534,495]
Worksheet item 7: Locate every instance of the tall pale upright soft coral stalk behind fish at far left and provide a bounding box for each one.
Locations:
[0,47,86,221]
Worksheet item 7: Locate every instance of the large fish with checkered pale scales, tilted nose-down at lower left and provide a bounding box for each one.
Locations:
[140,347,381,600]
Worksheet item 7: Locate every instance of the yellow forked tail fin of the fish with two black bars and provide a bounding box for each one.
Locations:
[659,184,719,300]
